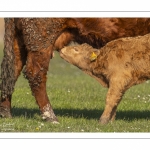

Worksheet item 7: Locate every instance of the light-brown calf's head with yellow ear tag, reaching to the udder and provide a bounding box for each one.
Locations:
[60,43,99,70]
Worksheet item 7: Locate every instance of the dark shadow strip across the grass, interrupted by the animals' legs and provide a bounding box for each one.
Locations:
[12,108,150,121]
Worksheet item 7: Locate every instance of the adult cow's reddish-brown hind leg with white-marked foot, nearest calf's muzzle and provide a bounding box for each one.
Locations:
[24,47,58,123]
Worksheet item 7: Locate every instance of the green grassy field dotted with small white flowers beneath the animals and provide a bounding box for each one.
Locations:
[0,42,150,133]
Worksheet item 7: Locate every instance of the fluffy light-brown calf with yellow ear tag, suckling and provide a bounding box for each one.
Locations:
[60,34,150,124]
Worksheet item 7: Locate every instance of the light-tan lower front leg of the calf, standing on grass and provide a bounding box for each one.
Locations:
[99,84,123,124]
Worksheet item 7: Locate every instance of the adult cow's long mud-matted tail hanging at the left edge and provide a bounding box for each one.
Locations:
[0,18,15,99]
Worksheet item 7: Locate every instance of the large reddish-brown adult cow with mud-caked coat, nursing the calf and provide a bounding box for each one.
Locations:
[0,18,150,122]
